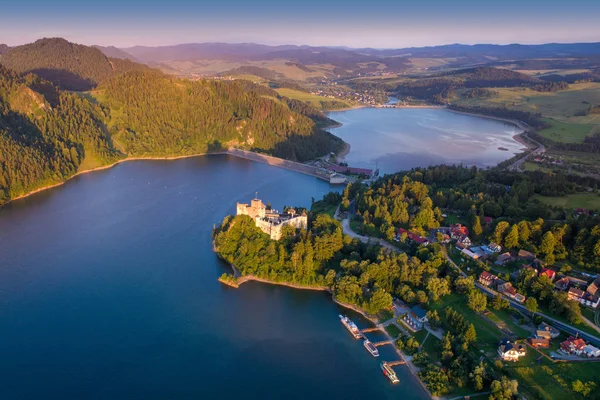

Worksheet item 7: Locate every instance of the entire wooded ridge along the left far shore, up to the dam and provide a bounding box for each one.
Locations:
[0,65,342,205]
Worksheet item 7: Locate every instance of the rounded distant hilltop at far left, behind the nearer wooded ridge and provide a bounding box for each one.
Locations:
[0,38,147,91]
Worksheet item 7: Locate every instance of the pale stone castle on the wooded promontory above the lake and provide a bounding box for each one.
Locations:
[236,198,308,240]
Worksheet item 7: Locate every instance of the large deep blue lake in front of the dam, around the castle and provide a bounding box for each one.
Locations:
[0,155,426,400]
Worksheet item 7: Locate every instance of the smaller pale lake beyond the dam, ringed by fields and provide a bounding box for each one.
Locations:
[327,108,524,174]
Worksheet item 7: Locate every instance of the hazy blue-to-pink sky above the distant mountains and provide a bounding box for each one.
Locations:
[0,0,600,48]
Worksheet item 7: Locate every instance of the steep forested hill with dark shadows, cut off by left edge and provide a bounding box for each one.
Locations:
[0,65,119,205]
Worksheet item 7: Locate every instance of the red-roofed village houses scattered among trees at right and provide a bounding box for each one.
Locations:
[394,218,600,368]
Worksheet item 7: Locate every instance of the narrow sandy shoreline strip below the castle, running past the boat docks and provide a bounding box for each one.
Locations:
[218,256,438,399]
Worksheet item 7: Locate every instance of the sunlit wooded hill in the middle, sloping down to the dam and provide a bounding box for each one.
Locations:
[94,70,341,161]
